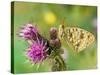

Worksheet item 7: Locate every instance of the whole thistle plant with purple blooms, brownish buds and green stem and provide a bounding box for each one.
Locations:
[19,24,66,71]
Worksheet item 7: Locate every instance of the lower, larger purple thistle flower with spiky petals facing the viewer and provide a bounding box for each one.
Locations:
[27,39,49,63]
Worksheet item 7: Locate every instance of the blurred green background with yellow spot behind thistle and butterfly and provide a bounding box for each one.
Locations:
[13,2,97,73]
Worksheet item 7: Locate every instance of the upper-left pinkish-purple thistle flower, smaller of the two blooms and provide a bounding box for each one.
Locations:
[19,24,38,40]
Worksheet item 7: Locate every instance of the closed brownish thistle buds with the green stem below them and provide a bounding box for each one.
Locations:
[50,27,66,71]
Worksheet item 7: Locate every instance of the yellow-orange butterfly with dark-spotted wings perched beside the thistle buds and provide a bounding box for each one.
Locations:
[58,24,95,53]
